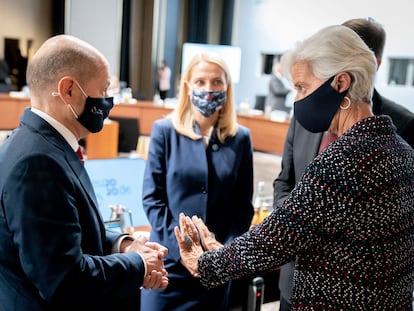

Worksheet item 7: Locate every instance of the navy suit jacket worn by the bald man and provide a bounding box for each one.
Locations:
[0,109,144,311]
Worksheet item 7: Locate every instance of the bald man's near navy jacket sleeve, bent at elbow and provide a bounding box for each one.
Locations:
[3,155,144,304]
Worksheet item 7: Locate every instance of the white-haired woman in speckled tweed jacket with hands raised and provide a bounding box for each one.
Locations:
[175,25,414,310]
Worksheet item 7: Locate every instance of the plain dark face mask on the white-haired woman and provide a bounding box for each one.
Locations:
[293,76,348,133]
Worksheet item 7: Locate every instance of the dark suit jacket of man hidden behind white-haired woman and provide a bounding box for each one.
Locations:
[273,90,414,301]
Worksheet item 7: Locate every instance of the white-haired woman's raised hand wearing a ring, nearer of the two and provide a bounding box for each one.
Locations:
[174,213,203,277]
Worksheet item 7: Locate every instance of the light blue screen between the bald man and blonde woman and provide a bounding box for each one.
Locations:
[85,158,149,226]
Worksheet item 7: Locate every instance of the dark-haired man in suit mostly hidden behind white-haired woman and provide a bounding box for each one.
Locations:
[273,18,414,311]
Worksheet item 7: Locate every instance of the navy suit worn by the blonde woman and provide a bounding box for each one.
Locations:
[141,118,253,310]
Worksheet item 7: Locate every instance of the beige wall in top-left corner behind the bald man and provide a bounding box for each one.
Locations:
[0,0,53,59]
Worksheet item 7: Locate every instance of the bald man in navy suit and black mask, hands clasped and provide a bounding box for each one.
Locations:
[0,35,168,311]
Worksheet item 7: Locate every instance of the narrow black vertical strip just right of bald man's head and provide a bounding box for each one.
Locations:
[119,0,131,85]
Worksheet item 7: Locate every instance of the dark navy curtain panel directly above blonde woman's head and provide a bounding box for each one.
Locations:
[188,0,210,43]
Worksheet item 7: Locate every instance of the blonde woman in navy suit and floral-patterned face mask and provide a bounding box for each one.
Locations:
[141,53,253,311]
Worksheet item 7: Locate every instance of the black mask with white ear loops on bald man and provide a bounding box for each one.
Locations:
[69,81,114,133]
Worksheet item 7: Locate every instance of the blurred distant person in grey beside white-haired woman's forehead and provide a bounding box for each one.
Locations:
[265,62,292,113]
